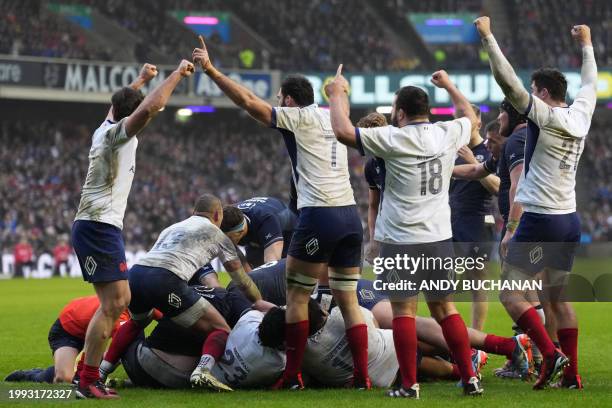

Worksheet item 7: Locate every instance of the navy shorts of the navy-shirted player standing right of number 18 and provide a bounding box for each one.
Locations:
[451,214,493,257]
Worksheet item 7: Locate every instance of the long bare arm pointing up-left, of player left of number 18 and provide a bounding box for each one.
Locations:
[193,36,272,126]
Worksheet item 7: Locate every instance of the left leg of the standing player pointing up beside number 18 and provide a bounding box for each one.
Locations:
[273,256,327,389]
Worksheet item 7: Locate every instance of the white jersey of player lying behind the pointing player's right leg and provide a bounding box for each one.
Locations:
[303,307,399,387]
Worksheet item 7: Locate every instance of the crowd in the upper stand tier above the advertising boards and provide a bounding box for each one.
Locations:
[0,0,612,71]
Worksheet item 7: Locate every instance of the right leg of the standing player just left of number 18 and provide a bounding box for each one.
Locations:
[329,267,371,389]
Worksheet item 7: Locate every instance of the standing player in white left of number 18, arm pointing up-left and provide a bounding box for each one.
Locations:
[193,37,370,389]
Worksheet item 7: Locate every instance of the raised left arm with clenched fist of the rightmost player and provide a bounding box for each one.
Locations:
[474,17,529,113]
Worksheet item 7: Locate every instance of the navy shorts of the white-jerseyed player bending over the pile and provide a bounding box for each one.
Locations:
[129,265,201,318]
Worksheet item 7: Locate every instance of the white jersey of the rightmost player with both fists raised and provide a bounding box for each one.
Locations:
[516,48,597,214]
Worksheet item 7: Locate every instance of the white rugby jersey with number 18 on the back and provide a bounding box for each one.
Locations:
[356,118,471,244]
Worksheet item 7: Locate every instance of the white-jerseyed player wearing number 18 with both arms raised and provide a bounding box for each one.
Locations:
[326,66,482,398]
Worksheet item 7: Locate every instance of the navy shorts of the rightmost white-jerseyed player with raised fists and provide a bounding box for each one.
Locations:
[505,212,580,274]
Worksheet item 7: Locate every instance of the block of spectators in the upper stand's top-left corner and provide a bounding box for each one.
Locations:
[0,0,110,60]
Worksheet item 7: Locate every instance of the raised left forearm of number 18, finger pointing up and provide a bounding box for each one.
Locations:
[325,64,357,148]
